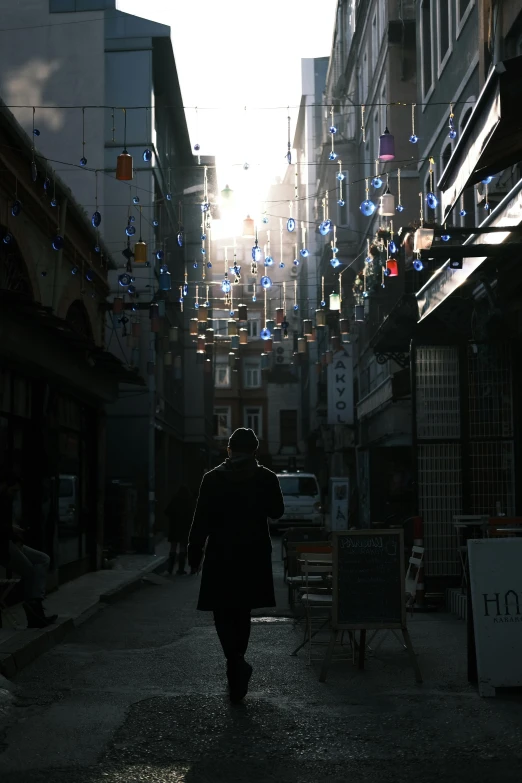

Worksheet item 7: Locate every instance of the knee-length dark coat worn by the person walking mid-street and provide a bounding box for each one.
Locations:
[188,457,285,611]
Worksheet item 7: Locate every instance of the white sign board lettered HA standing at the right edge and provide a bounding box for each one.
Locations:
[468,538,522,696]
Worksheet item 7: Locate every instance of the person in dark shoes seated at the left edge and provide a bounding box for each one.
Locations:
[0,474,58,628]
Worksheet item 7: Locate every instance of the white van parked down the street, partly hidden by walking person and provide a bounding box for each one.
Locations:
[270,471,323,530]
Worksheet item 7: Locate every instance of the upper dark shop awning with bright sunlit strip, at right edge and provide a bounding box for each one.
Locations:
[438,56,522,218]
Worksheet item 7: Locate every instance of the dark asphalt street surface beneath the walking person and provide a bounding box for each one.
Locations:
[0,542,522,783]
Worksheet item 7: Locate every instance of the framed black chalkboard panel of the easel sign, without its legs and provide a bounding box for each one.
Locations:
[332,530,406,630]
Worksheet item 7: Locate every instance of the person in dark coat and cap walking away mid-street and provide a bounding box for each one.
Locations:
[188,428,285,703]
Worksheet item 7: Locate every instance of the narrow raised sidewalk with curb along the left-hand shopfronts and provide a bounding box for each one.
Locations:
[0,555,169,678]
